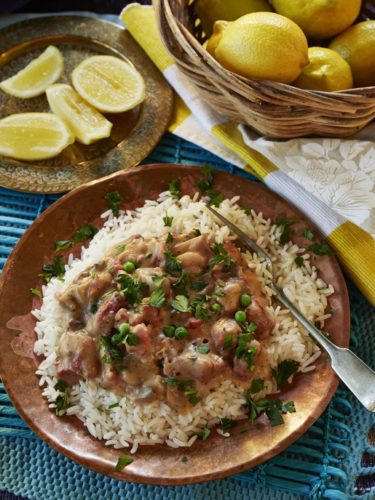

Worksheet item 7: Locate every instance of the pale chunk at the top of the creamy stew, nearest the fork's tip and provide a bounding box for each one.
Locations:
[174,235,212,276]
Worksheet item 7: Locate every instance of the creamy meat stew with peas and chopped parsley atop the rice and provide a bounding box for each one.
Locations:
[57,235,274,412]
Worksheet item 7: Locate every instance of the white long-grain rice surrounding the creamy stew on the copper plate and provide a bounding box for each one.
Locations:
[33,191,333,453]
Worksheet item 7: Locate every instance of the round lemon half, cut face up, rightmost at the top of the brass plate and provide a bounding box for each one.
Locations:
[72,56,145,113]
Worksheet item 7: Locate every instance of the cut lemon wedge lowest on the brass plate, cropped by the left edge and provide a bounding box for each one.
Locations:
[0,113,74,160]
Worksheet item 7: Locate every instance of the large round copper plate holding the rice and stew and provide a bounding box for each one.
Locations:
[0,164,349,485]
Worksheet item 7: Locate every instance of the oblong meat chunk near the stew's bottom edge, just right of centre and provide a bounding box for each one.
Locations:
[164,348,227,383]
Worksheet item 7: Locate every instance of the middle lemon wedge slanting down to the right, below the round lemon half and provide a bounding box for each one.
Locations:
[46,83,112,144]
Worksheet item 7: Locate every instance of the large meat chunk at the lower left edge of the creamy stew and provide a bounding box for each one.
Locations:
[57,330,100,385]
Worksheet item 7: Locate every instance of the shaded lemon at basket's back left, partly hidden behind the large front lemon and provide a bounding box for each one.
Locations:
[194,0,272,36]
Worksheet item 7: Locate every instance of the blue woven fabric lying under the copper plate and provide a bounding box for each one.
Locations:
[0,134,375,500]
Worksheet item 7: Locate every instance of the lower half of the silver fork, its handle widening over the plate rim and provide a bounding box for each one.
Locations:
[272,285,375,412]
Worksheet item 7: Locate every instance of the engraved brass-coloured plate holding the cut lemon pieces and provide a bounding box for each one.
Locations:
[0,16,173,193]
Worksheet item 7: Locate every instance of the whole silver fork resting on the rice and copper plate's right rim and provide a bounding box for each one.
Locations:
[207,205,375,412]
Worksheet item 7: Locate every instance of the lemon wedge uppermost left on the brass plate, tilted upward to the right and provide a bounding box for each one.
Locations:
[0,45,64,99]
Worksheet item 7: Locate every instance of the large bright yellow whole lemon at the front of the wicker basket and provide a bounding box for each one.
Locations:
[208,12,308,83]
